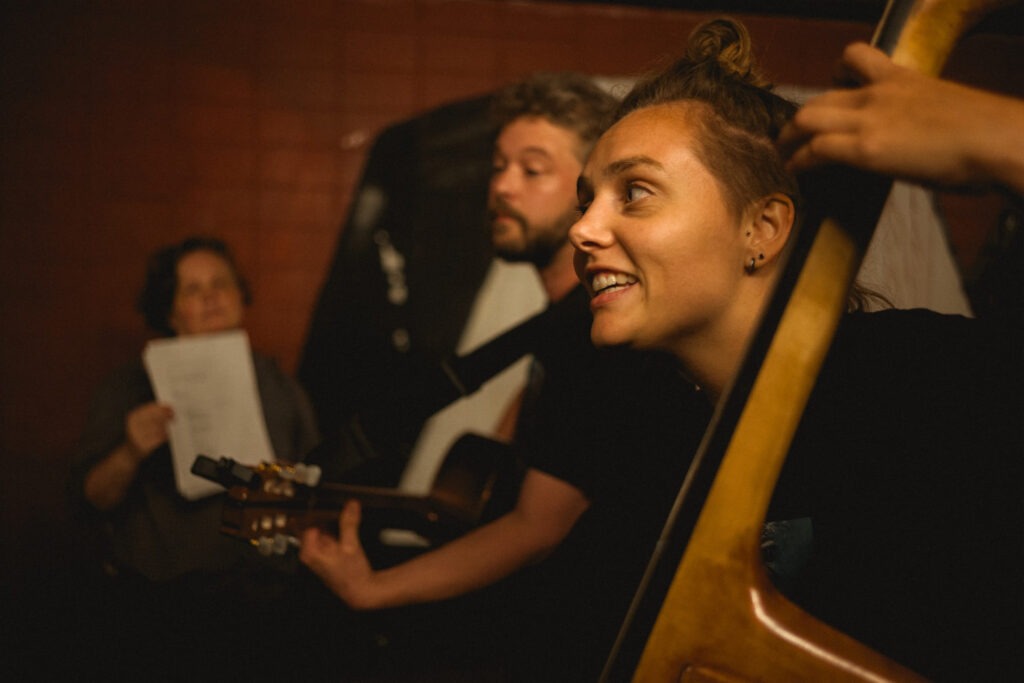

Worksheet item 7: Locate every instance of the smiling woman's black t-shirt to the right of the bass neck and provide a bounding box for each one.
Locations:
[766,310,1024,680]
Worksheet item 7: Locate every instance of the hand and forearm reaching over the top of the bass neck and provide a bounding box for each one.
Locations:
[778,43,1024,194]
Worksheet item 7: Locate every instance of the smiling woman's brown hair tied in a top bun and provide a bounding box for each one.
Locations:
[613,17,800,212]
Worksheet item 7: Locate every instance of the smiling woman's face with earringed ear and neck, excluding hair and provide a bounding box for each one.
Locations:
[572,103,795,389]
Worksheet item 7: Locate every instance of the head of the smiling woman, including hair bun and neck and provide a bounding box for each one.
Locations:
[570,17,799,397]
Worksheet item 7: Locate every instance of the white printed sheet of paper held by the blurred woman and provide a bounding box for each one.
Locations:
[142,330,274,500]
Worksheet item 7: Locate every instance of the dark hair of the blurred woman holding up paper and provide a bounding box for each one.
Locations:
[135,237,252,337]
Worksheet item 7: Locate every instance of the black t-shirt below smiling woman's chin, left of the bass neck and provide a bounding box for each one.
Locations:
[511,291,710,681]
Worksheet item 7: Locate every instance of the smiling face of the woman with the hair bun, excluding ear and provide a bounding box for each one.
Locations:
[569,103,749,353]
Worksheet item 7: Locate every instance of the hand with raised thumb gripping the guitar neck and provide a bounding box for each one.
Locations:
[299,500,385,609]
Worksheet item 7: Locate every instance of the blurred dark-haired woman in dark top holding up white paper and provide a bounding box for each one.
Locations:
[70,238,318,676]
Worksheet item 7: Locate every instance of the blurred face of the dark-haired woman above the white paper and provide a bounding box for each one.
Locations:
[170,250,245,336]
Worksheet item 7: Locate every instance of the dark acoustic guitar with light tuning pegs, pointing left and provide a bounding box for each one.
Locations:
[191,433,517,555]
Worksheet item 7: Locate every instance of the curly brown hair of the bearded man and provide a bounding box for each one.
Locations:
[490,72,618,161]
